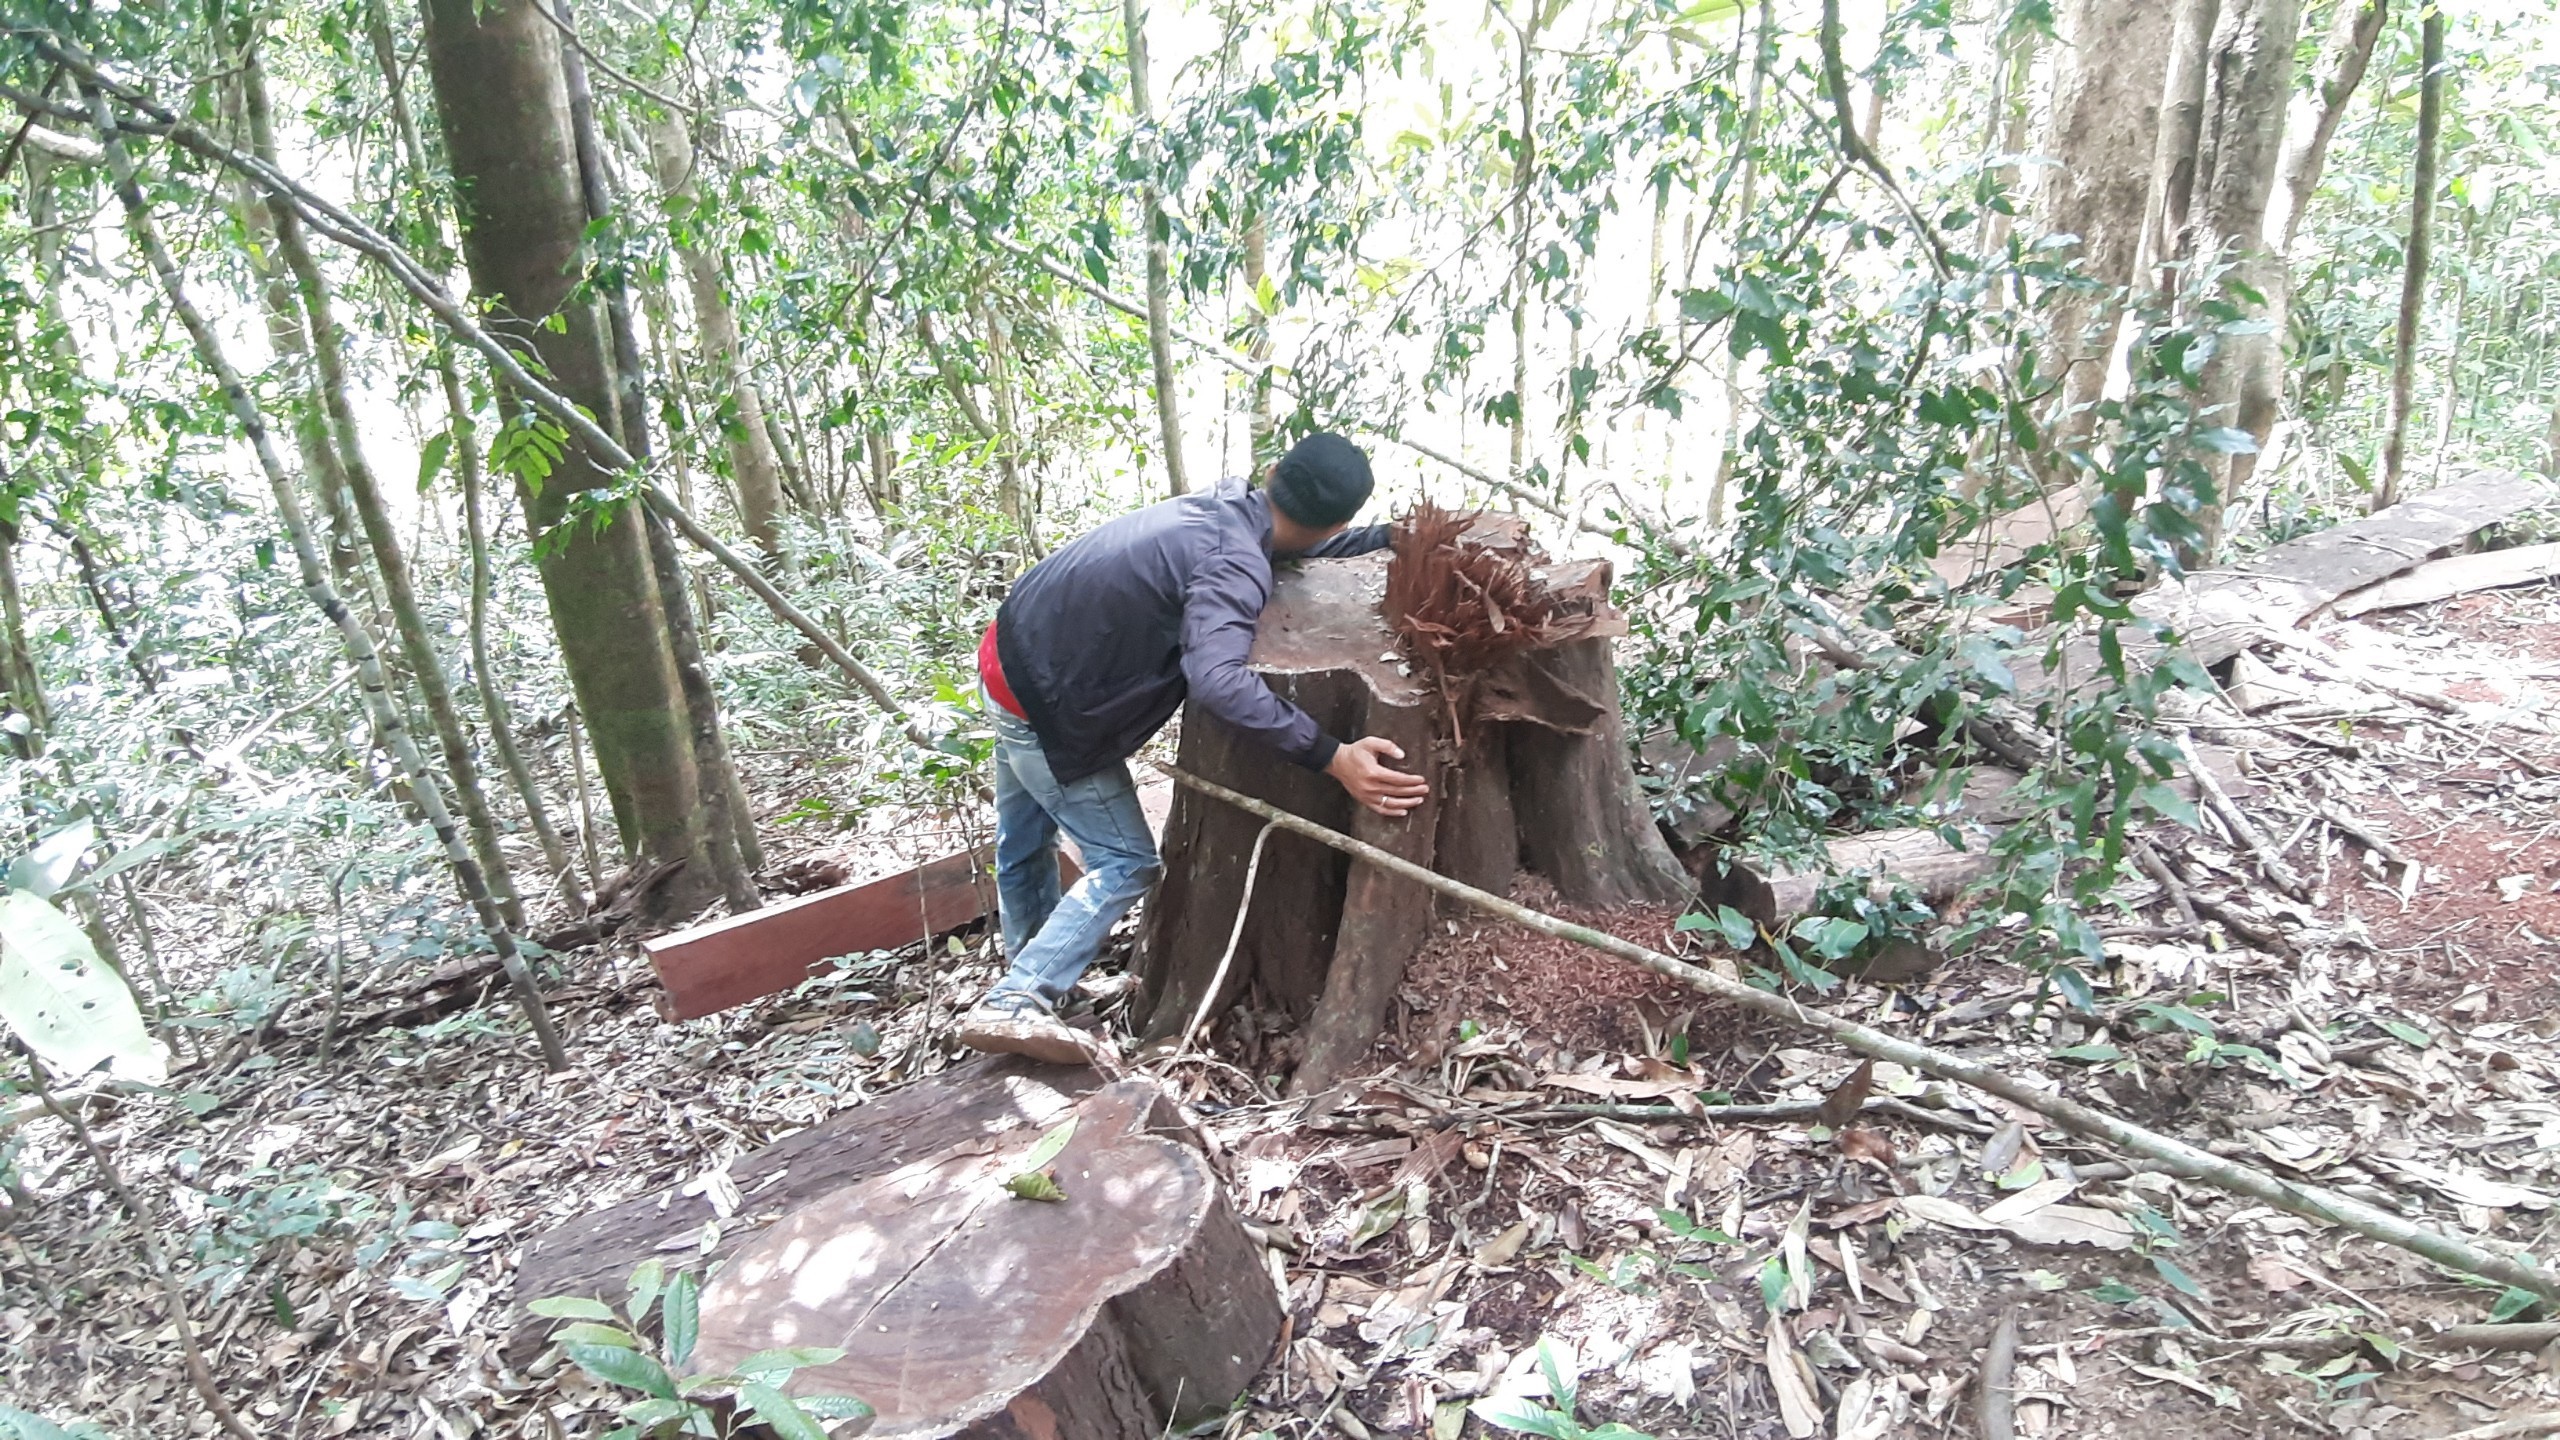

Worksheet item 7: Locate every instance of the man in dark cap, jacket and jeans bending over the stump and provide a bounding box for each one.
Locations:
[960,433,1428,1063]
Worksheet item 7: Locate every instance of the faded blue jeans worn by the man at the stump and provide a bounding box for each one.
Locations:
[986,700,1162,1010]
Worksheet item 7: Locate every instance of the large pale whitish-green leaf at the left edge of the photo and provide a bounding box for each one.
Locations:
[0,889,169,1084]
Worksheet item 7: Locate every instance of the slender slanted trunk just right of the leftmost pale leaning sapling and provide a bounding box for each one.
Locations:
[241,46,525,930]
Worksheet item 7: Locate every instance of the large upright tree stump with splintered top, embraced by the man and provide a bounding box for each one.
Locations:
[1137,518,1692,1094]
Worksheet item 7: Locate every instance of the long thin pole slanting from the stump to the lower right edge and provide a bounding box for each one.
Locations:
[1155,761,2560,1299]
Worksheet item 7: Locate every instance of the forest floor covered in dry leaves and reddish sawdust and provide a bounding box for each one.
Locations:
[0,589,2560,1440]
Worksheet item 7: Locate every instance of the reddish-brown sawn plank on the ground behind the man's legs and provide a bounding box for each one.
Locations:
[640,781,1172,1020]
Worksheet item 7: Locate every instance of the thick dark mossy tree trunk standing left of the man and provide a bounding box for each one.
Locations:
[425,0,717,912]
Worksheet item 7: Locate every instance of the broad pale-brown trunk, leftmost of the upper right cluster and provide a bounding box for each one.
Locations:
[2033,0,2173,453]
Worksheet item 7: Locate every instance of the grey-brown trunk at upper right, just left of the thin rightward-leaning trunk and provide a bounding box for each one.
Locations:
[2186,0,2301,564]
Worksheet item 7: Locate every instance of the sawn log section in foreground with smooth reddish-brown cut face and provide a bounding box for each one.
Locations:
[691,1081,1280,1440]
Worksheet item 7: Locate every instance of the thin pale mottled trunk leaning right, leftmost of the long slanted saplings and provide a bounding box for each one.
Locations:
[92,92,568,1071]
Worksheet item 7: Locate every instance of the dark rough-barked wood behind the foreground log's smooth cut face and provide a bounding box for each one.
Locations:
[507,1040,1101,1366]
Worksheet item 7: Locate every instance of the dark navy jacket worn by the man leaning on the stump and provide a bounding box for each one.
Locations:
[996,482,1388,784]
